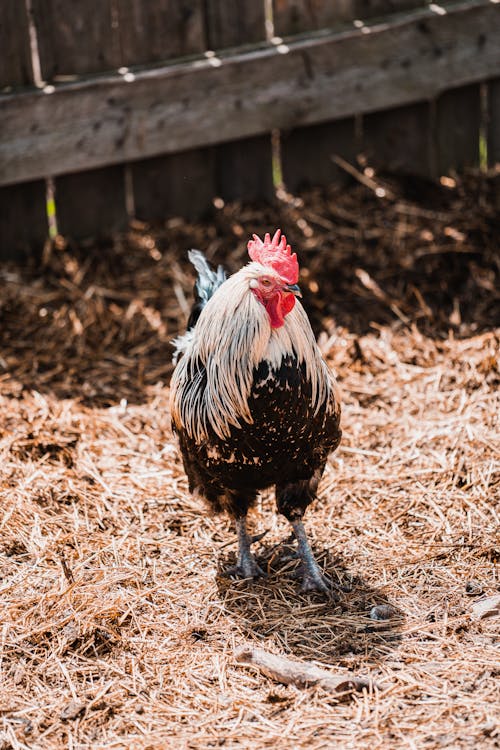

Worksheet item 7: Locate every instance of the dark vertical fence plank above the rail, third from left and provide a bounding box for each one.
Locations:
[115,0,206,66]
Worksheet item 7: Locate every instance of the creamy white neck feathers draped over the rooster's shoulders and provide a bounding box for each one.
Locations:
[170,263,334,443]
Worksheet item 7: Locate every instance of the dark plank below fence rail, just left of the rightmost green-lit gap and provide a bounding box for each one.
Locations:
[435,86,481,176]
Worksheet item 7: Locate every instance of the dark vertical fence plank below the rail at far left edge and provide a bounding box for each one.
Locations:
[0,180,48,260]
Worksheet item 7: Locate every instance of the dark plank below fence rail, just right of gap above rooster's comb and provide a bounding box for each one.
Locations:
[281,117,357,191]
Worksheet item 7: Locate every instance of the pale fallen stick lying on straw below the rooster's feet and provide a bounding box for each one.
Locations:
[236,646,381,694]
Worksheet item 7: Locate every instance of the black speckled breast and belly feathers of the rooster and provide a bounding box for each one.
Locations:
[174,355,341,520]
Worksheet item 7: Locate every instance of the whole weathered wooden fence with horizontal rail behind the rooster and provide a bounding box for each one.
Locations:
[0,0,500,258]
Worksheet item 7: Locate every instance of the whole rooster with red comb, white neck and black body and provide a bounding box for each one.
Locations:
[170,229,341,594]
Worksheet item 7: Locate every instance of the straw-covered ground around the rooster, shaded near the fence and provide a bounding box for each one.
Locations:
[0,176,500,750]
